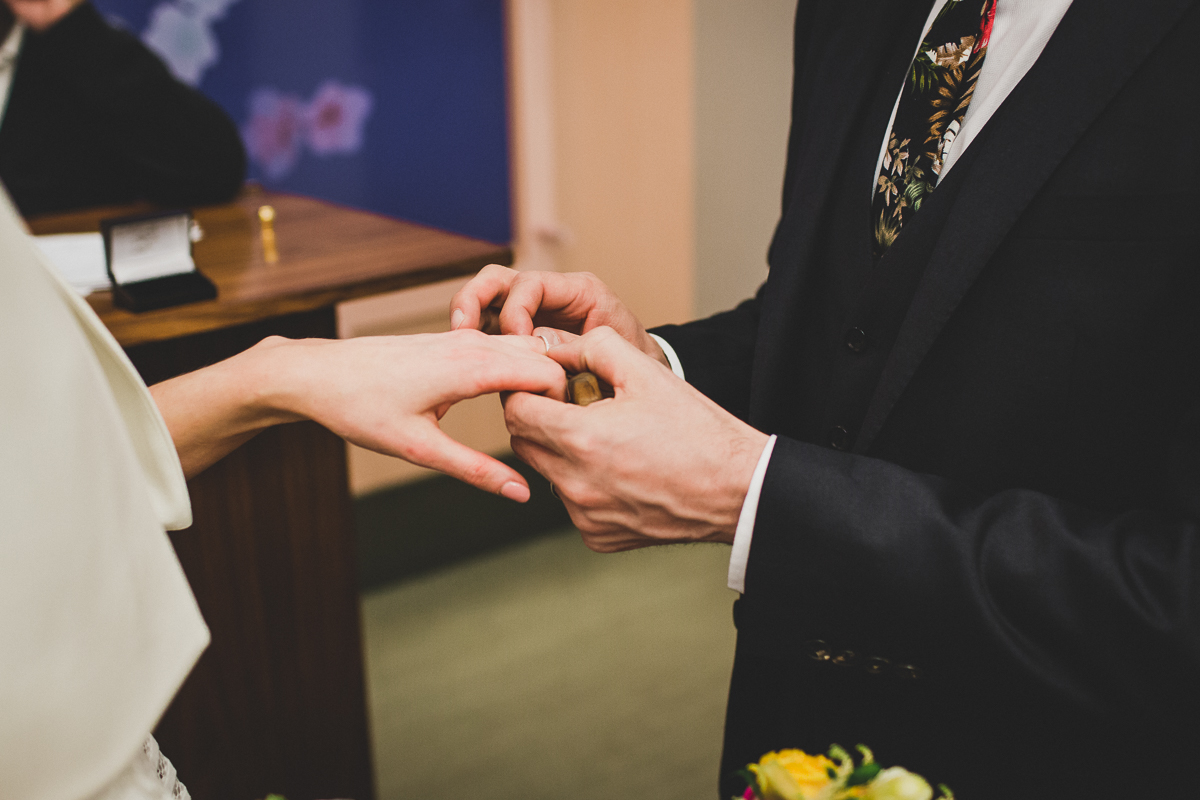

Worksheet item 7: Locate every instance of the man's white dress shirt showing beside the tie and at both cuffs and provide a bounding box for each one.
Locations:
[654,0,1072,591]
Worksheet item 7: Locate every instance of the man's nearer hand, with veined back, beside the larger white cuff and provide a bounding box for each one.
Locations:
[504,327,767,552]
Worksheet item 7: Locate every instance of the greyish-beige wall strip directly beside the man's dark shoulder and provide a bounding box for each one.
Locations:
[695,0,796,315]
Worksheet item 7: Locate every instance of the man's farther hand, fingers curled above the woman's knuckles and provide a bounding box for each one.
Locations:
[450,264,667,365]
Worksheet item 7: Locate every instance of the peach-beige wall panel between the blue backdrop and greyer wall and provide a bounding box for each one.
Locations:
[551,0,695,325]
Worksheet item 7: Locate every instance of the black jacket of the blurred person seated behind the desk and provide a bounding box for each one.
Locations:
[0,4,246,216]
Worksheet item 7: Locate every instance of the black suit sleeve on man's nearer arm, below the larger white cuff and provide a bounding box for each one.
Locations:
[739,407,1200,727]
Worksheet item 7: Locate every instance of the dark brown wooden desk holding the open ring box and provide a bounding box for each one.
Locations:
[30,192,511,800]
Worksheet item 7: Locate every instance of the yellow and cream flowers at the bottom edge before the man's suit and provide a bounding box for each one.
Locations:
[733,745,954,800]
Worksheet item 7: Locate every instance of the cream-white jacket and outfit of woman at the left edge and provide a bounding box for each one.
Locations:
[0,190,209,800]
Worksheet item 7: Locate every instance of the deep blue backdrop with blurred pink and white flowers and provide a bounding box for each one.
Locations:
[95,0,511,242]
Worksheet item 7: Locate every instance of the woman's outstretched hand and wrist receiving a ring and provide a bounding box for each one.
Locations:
[151,330,566,503]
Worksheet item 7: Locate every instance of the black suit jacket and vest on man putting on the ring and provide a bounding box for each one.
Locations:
[658,0,1200,798]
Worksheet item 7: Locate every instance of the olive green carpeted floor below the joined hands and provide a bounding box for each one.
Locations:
[364,530,736,800]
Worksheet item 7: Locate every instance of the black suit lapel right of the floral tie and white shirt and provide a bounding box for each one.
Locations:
[854,0,1196,452]
